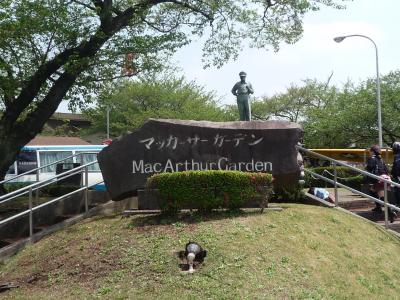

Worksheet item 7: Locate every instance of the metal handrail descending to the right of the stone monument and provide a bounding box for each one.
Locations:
[296,146,400,228]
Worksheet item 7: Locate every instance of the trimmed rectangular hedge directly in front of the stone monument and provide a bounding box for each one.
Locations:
[147,170,272,213]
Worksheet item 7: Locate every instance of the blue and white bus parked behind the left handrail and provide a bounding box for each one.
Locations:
[5,145,106,188]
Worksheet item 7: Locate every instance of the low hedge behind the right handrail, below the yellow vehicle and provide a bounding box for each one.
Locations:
[304,167,364,189]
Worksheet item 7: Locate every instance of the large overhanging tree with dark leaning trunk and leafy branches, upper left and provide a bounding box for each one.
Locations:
[0,0,345,179]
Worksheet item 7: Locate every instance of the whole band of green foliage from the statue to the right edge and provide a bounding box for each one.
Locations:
[252,70,400,148]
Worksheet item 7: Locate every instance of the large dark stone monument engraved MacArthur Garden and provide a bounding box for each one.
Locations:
[98,119,302,200]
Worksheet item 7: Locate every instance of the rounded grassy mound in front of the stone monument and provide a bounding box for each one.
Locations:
[0,204,400,299]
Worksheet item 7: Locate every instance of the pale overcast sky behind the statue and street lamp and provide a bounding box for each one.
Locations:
[59,0,400,111]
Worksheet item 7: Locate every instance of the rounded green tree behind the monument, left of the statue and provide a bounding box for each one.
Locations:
[84,77,229,137]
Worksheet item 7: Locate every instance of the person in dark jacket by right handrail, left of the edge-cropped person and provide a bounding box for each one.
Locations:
[366,145,396,222]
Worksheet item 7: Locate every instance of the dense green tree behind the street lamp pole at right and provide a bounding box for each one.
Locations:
[304,71,400,147]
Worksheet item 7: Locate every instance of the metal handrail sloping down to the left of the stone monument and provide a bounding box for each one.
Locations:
[0,160,103,237]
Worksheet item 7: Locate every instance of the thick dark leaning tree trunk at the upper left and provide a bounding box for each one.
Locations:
[0,1,139,193]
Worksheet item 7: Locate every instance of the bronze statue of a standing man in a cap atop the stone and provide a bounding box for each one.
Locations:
[232,71,254,121]
